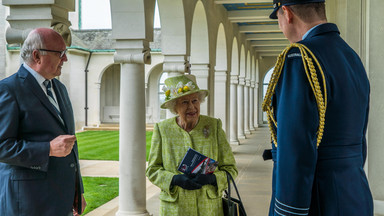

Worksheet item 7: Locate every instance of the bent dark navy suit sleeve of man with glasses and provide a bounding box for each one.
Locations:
[0,84,50,171]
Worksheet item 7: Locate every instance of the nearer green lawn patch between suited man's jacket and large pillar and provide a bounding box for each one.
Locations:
[83,177,119,215]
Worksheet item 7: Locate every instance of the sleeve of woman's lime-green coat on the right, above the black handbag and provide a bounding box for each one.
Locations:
[214,119,238,197]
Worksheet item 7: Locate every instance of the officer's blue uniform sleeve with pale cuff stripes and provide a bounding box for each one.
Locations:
[274,53,319,215]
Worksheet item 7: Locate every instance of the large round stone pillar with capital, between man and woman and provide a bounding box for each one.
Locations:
[114,40,150,216]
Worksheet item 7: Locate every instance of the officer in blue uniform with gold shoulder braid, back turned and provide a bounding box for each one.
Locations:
[263,0,373,216]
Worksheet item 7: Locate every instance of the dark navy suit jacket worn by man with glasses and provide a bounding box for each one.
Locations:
[0,66,83,216]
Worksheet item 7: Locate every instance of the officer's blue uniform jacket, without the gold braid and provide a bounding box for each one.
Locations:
[269,23,373,216]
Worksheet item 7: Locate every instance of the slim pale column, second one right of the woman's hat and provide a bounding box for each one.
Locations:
[229,76,240,145]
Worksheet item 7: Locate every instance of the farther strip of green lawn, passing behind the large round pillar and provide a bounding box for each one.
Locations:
[76,131,152,161]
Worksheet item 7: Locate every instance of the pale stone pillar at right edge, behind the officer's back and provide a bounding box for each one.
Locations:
[366,0,384,215]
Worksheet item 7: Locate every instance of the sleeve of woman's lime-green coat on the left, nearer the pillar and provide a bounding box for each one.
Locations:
[146,124,178,196]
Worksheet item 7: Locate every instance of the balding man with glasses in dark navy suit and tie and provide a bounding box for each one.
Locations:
[0,28,86,216]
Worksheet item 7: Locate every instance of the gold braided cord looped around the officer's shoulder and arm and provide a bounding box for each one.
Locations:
[262,43,327,147]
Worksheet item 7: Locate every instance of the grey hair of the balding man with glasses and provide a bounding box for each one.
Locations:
[20,31,46,63]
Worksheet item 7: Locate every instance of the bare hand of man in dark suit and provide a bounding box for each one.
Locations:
[49,135,76,157]
